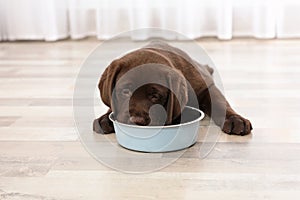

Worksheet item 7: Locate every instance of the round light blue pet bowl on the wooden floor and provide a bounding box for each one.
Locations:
[109,106,204,152]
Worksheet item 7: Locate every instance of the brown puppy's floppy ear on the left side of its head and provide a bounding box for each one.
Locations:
[98,60,121,108]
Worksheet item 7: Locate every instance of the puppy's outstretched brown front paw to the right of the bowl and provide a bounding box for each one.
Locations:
[222,115,252,135]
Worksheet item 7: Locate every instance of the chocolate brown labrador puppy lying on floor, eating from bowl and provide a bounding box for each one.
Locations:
[93,41,252,135]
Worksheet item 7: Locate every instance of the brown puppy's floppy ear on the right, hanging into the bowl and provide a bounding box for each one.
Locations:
[167,70,188,124]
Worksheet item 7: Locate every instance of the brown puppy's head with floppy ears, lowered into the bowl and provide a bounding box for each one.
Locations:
[99,61,188,126]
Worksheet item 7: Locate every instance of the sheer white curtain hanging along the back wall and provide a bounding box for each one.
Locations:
[0,0,300,41]
